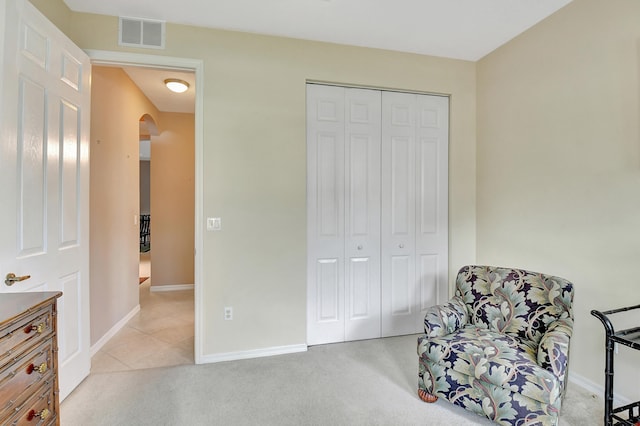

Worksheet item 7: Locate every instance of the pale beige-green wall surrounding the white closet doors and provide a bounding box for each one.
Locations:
[30,0,476,357]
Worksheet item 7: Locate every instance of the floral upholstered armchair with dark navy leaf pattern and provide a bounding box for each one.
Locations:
[418,266,573,425]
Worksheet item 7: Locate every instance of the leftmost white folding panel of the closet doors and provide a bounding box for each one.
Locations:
[307,85,345,344]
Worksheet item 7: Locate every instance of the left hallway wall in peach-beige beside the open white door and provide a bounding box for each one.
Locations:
[90,66,158,345]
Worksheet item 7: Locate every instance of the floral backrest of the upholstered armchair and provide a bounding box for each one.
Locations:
[456,265,573,345]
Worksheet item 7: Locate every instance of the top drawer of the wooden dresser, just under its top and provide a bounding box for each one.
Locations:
[0,305,53,368]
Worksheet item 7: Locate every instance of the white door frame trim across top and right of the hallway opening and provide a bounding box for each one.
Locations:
[85,49,205,364]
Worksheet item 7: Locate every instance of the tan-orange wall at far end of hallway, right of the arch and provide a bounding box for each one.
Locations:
[151,112,195,287]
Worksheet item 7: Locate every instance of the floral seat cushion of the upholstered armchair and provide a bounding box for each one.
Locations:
[418,324,561,405]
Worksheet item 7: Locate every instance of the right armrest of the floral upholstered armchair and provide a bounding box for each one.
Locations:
[538,318,573,381]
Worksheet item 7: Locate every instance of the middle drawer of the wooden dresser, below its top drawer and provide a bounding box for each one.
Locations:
[0,339,55,424]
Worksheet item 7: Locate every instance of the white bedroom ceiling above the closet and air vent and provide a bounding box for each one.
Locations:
[64,0,571,61]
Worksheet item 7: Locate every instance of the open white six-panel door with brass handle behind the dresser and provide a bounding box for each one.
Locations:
[0,0,91,400]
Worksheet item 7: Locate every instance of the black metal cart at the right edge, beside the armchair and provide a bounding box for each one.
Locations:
[591,305,640,426]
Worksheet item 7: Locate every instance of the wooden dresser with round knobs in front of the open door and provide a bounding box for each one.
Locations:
[0,292,62,426]
